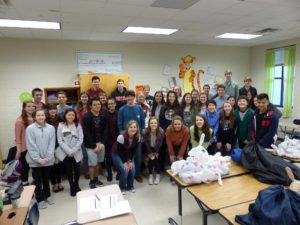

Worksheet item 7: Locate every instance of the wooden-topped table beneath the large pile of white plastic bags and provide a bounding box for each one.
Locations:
[166,160,250,224]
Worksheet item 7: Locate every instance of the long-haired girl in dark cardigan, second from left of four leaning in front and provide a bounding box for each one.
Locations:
[143,116,164,185]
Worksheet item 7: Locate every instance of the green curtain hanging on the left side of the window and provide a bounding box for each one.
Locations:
[265,49,275,102]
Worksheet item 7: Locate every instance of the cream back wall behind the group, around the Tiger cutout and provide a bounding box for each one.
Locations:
[0,38,250,158]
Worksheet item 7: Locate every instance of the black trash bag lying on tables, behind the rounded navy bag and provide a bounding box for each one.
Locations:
[241,143,300,186]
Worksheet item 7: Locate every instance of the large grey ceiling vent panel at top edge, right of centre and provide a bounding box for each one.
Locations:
[151,0,200,10]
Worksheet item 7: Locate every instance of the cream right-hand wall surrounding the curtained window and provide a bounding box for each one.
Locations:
[250,38,300,120]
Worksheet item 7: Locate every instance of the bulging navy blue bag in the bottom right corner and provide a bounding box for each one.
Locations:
[235,185,300,225]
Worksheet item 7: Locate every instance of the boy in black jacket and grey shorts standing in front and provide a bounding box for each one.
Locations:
[82,98,107,188]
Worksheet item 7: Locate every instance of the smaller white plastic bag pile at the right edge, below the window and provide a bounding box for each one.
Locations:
[272,136,300,158]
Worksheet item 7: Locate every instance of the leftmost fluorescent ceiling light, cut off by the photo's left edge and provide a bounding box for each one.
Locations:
[0,19,60,30]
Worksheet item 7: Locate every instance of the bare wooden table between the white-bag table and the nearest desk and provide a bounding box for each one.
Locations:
[187,174,269,225]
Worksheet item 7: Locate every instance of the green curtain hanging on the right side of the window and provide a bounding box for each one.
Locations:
[282,46,296,117]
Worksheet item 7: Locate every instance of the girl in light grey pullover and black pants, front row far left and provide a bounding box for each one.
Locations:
[26,109,55,209]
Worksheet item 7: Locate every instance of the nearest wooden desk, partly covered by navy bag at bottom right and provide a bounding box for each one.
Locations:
[219,201,254,225]
